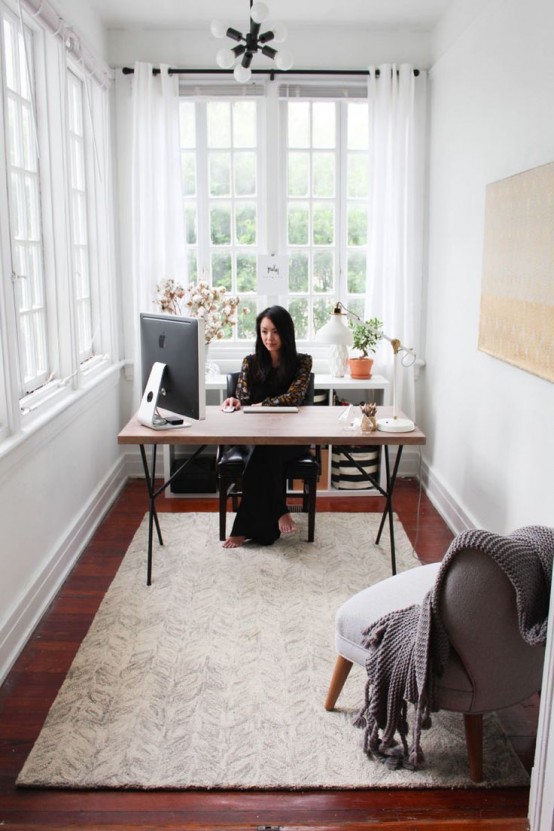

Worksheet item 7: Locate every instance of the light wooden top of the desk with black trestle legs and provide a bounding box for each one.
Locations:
[117,405,425,446]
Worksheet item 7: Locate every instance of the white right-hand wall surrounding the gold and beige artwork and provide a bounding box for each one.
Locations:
[419,0,554,533]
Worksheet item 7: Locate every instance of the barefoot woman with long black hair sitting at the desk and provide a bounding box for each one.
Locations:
[223,306,312,548]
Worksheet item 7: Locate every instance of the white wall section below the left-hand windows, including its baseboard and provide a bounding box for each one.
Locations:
[0,367,127,683]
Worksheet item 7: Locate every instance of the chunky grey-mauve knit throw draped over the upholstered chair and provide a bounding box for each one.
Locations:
[355,525,554,769]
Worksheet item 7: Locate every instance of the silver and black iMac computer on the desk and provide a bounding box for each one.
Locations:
[137,313,206,430]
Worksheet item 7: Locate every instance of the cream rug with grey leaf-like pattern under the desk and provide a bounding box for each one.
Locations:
[18,513,528,789]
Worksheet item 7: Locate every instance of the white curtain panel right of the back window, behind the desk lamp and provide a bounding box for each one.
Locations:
[365,64,426,419]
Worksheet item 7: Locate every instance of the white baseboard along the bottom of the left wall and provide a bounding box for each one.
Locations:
[0,459,127,684]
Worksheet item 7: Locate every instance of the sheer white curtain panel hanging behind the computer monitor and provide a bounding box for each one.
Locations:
[130,63,187,398]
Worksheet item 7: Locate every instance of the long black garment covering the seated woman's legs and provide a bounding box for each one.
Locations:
[227,444,307,545]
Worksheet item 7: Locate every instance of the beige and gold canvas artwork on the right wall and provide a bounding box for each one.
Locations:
[479,162,554,381]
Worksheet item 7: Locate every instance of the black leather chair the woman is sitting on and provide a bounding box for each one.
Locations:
[217,372,321,542]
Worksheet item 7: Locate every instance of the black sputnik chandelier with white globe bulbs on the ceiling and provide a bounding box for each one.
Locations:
[211,0,293,84]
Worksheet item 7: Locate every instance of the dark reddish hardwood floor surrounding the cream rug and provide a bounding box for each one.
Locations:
[0,479,538,831]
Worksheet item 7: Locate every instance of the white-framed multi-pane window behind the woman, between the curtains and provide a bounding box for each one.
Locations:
[181,81,369,343]
